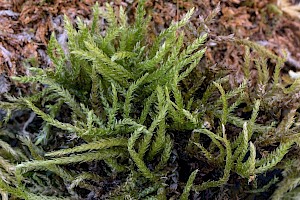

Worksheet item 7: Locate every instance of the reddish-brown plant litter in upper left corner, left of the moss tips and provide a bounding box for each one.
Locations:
[0,0,101,76]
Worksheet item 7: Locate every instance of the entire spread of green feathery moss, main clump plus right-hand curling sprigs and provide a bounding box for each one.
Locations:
[0,1,299,199]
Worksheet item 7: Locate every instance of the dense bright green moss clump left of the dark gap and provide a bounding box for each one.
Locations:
[1,1,207,197]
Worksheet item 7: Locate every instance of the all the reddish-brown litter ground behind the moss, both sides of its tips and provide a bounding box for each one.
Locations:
[0,0,300,199]
